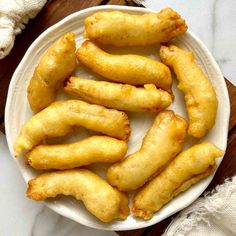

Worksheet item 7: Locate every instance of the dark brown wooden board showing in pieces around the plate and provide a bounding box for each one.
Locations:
[0,0,236,236]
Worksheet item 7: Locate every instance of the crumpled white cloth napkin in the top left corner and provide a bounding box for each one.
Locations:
[0,0,47,59]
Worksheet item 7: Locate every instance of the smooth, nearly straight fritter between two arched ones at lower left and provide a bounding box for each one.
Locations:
[26,136,128,170]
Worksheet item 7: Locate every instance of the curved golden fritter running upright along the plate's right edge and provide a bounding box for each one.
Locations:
[160,45,218,138]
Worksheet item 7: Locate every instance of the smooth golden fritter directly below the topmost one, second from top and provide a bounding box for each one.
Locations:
[76,41,172,91]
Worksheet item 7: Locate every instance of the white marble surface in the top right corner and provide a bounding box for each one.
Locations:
[136,0,236,86]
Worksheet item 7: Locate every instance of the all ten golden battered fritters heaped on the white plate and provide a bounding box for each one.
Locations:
[14,8,224,222]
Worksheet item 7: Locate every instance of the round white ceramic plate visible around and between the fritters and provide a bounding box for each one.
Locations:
[5,6,230,230]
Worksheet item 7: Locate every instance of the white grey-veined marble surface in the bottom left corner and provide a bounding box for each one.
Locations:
[0,132,117,236]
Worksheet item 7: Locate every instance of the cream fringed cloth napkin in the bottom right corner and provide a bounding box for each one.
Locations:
[163,176,236,236]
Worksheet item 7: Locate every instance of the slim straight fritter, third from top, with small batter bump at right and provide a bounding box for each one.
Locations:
[65,77,172,112]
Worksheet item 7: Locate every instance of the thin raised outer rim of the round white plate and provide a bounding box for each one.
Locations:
[4,5,230,231]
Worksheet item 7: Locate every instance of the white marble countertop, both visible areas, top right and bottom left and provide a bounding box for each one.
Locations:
[0,0,236,236]
